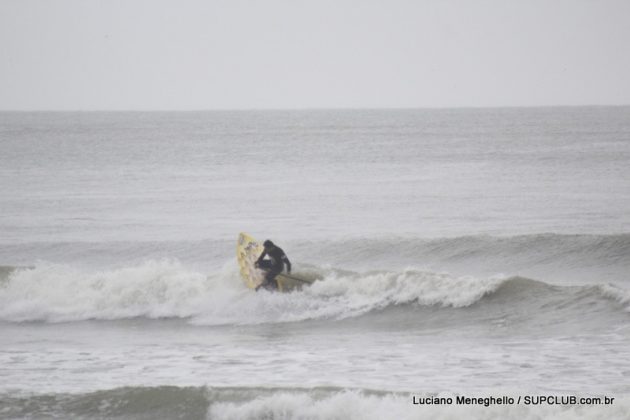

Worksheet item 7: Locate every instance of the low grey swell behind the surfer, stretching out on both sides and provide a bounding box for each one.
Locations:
[0,233,630,276]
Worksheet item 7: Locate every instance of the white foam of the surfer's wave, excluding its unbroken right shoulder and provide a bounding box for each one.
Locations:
[0,260,504,325]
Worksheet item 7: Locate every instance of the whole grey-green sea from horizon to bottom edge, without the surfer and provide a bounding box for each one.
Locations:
[0,107,630,419]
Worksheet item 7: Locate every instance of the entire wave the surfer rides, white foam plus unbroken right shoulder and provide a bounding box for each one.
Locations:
[0,260,630,325]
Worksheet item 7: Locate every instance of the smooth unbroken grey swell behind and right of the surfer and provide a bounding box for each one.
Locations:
[302,233,630,280]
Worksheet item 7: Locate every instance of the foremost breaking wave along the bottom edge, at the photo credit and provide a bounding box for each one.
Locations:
[0,386,630,420]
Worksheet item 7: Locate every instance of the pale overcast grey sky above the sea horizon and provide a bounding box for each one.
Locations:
[0,0,630,110]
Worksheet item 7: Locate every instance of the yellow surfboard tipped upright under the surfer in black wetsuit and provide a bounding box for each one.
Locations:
[236,233,314,292]
